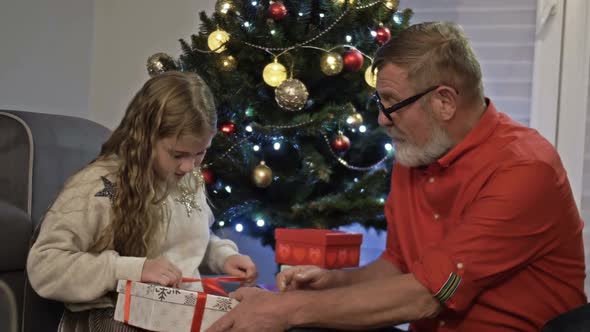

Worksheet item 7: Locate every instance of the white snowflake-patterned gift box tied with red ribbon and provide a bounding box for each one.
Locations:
[115,280,238,332]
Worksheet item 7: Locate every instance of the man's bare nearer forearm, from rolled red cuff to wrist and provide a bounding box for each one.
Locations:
[283,274,440,330]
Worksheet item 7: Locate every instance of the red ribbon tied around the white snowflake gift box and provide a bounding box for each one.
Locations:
[123,277,246,332]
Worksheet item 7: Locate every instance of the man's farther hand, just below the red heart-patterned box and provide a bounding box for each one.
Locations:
[276,265,338,292]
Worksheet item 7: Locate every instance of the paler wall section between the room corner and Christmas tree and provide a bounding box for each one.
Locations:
[90,0,215,128]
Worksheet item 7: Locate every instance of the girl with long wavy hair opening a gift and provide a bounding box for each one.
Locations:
[27,72,256,332]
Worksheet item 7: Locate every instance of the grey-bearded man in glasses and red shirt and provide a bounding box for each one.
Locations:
[209,22,586,332]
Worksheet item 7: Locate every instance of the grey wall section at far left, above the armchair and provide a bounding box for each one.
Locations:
[0,0,94,118]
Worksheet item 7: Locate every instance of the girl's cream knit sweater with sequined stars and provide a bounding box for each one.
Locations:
[27,159,238,311]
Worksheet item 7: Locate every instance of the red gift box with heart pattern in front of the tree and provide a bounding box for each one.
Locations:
[275,228,363,269]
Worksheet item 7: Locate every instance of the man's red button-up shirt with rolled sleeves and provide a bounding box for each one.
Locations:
[382,102,586,332]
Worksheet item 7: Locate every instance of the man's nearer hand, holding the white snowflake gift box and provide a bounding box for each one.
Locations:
[206,287,290,332]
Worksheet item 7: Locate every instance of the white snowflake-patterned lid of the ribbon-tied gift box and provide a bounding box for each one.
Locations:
[117,280,239,311]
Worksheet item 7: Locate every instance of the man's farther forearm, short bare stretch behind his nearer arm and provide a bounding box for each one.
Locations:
[332,258,402,287]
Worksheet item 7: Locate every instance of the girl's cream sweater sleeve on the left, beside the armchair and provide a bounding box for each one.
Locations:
[27,171,145,303]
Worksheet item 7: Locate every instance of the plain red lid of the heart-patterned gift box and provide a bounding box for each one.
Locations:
[275,228,363,246]
